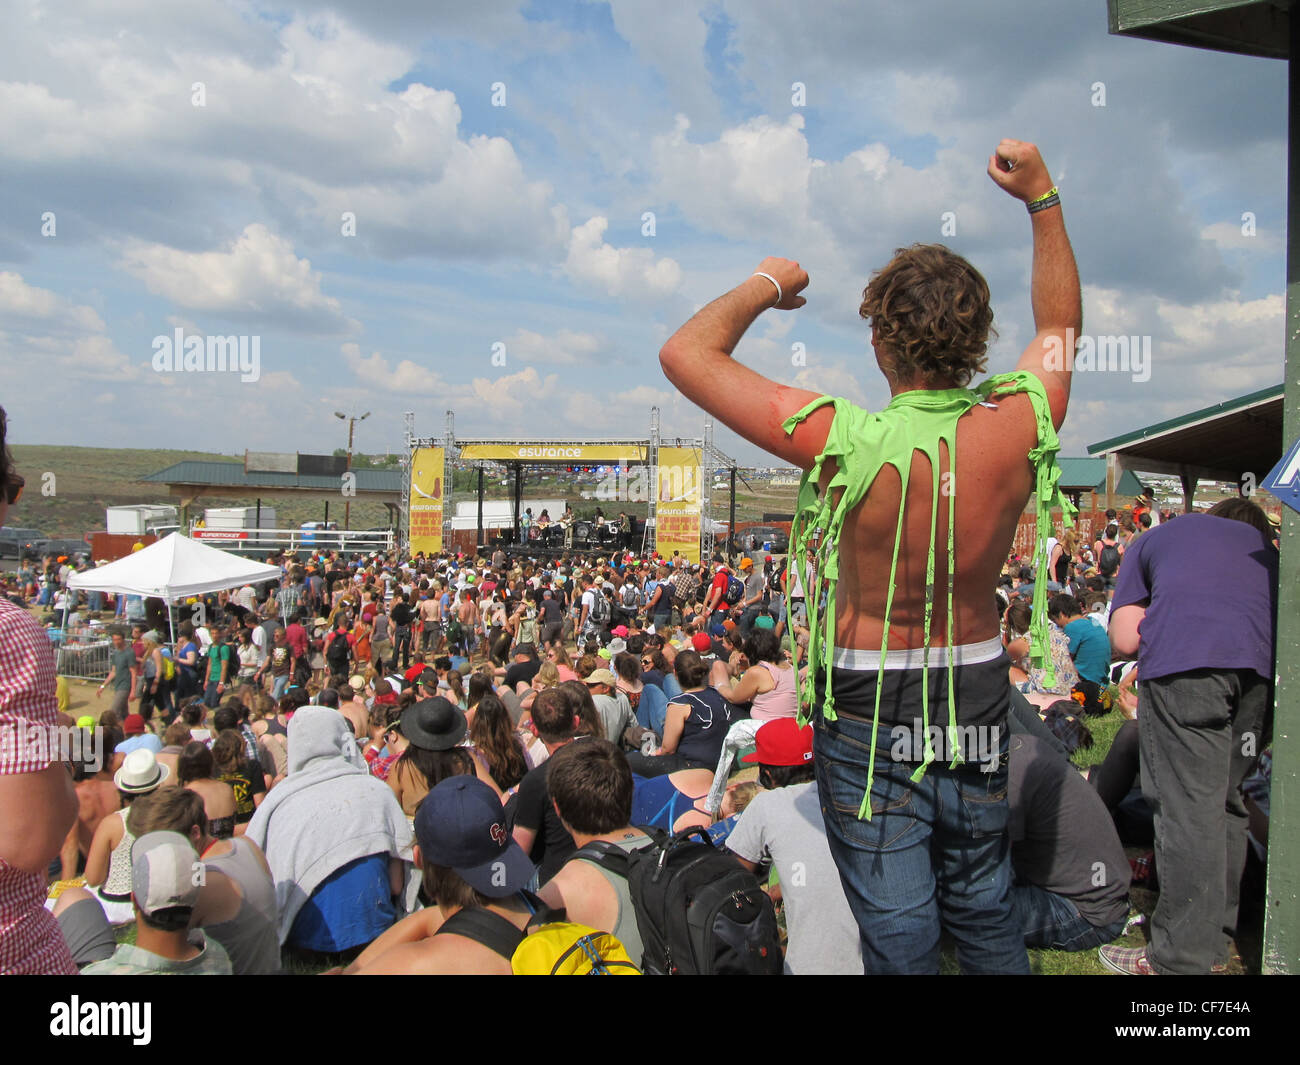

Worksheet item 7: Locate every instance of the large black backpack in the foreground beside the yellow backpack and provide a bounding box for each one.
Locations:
[577,827,784,977]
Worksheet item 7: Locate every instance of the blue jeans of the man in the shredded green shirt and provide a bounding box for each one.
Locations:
[814,706,1030,974]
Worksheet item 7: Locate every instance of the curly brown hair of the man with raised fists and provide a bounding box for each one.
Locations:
[858,244,997,388]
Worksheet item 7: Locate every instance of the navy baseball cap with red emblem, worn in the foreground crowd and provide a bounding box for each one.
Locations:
[415,776,536,899]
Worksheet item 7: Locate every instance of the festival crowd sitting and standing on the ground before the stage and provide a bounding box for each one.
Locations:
[0,486,1266,973]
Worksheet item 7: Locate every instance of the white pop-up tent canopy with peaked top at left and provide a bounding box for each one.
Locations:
[68,533,281,602]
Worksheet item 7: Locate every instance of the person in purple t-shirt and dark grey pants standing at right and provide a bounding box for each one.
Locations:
[1101,499,1278,975]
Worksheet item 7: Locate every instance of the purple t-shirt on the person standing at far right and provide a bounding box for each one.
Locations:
[1112,514,1278,680]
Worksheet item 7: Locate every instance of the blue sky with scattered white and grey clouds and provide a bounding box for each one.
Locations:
[0,0,1286,463]
